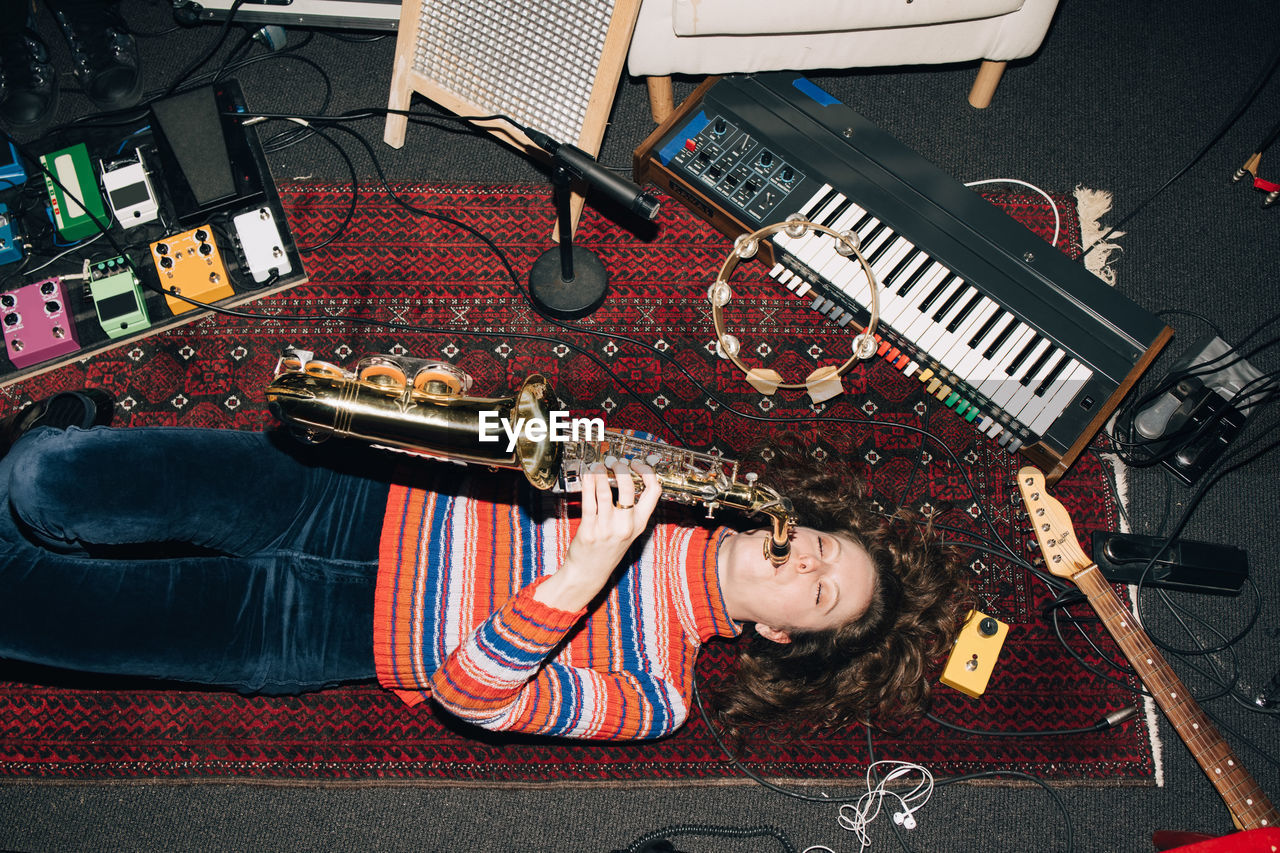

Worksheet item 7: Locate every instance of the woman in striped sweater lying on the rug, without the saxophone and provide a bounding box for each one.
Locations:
[0,392,968,740]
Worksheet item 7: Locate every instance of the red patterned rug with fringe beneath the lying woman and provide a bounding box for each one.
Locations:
[0,184,1153,785]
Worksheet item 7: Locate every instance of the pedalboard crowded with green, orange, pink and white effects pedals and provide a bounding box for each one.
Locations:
[0,78,307,388]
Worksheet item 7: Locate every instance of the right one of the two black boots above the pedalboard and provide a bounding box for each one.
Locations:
[54,3,142,110]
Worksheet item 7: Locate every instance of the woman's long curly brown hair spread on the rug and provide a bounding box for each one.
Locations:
[716,435,972,729]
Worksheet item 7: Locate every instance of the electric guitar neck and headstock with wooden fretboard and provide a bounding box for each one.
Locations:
[1018,466,1280,830]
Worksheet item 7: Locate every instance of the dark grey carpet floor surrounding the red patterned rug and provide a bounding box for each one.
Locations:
[0,0,1280,852]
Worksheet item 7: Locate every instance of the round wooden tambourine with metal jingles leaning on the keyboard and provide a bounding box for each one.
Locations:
[707,214,879,394]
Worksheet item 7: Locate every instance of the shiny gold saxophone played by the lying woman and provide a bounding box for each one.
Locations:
[266,350,795,565]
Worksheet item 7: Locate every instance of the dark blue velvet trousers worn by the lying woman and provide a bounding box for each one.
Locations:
[0,428,394,693]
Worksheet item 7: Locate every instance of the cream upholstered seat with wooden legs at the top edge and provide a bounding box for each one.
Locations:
[627,0,1057,122]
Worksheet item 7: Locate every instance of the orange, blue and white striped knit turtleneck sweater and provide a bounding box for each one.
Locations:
[374,466,741,740]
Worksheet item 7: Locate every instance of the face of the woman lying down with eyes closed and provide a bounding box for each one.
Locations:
[718,528,876,643]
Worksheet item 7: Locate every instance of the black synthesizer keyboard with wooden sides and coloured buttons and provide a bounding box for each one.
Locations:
[635,73,1172,482]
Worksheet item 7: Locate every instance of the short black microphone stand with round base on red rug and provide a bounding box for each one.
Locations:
[529,156,609,320]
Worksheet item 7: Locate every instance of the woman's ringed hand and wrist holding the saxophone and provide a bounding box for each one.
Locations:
[534,461,662,611]
